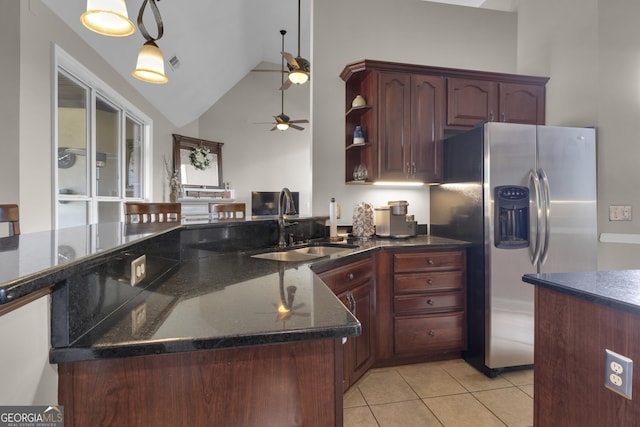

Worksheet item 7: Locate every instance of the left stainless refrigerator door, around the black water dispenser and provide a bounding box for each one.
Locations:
[484,123,536,369]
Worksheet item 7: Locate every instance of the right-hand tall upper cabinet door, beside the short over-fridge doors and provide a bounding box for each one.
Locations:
[409,75,444,182]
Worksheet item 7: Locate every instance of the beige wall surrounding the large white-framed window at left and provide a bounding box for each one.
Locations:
[12,0,191,233]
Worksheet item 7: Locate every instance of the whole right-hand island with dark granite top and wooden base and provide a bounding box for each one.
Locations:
[522,270,640,427]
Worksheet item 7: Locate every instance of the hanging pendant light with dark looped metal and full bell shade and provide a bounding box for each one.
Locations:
[131,0,169,84]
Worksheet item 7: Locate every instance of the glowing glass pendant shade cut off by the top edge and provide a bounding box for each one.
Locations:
[80,0,136,37]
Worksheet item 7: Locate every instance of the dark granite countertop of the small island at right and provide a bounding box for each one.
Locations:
[522,270,640,315]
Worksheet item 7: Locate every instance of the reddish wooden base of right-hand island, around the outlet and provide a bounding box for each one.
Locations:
[534,286,640,427]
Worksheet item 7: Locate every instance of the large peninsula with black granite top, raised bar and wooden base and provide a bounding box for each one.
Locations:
[0,217,464,426]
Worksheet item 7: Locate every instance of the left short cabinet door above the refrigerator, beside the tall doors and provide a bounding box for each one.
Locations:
[447,78,499,128]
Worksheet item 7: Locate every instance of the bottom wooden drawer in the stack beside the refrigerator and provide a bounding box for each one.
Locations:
[394,312,465,353]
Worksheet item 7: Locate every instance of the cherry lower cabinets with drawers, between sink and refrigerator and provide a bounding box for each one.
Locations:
[314,248,467,390]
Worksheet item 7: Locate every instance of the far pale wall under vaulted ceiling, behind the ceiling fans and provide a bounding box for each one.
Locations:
[199,61,312,215]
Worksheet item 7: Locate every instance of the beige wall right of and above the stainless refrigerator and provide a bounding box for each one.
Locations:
[518,0,640,270]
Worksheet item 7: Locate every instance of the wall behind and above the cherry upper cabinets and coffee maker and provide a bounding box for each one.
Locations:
[311,0,517,224]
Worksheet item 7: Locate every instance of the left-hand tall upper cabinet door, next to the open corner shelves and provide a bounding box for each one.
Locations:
[378,72,411,180]
